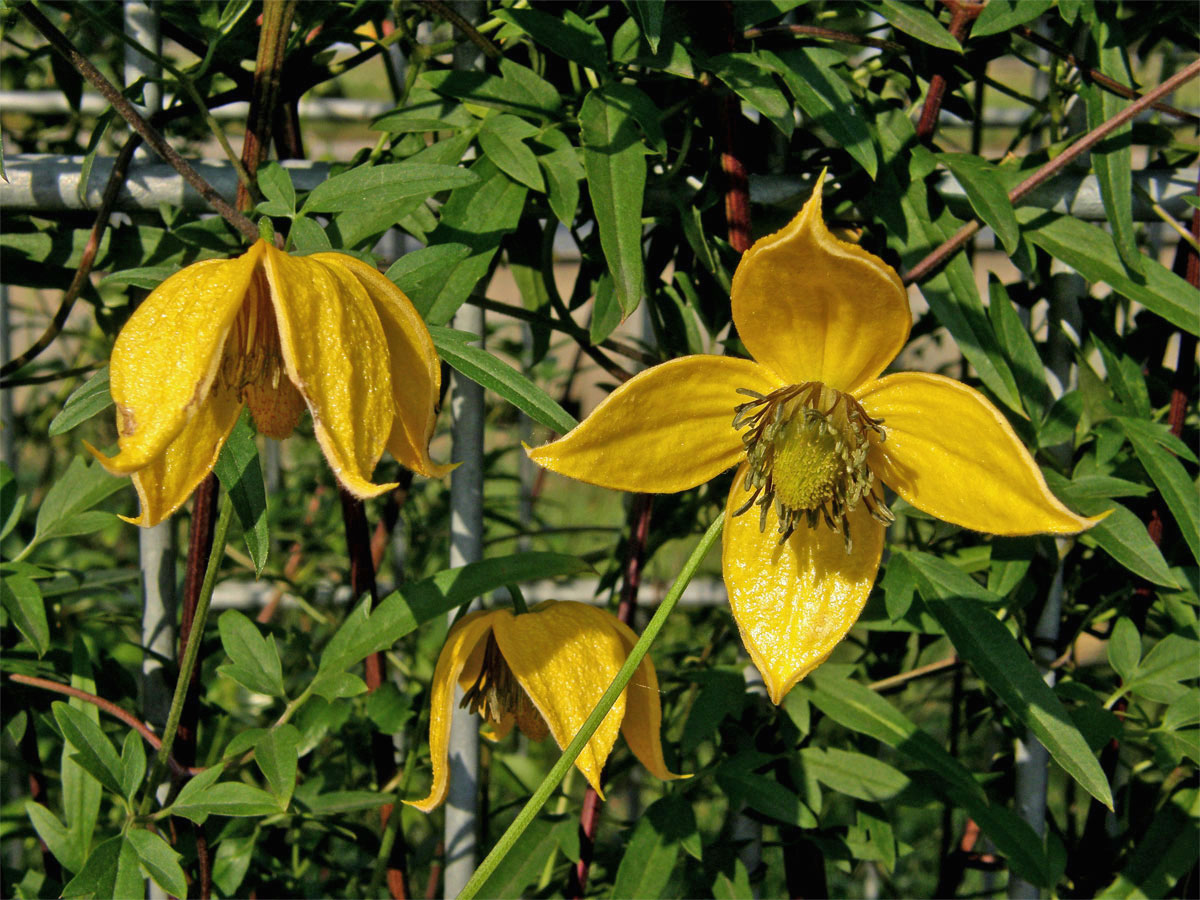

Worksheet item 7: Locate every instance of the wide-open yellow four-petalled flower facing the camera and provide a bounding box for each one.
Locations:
[529,170,1099,703]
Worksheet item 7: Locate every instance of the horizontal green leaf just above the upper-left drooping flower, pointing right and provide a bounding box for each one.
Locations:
[301,162,479,212]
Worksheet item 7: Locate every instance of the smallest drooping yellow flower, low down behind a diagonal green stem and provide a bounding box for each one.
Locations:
[407,600,679,812]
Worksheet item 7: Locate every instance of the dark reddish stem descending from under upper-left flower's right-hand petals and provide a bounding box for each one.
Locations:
[337,485,408,900]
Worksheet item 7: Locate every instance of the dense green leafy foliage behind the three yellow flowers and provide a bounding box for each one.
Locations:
[0,0,1200,898]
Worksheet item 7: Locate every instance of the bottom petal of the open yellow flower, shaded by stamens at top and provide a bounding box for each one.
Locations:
[721,467,884,703]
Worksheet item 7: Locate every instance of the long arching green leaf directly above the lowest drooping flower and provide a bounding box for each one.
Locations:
[317,553,590,673]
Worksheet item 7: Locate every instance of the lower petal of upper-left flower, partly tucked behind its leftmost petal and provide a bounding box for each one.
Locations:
[126,390,242,528]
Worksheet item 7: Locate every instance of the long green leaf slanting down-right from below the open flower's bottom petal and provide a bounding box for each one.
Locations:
[810,671,1051,884]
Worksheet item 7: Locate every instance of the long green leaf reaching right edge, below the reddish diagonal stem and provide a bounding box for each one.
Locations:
[1016,208,1200,335]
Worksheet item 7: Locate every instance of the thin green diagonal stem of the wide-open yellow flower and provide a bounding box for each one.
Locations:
[458,512,725,900]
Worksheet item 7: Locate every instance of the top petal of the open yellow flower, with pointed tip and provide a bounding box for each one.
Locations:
[731,176,912,391]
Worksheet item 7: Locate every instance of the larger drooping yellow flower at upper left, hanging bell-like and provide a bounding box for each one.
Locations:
[88,240,450,526]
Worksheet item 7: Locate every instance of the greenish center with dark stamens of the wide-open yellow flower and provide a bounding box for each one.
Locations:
[733,382,893,551]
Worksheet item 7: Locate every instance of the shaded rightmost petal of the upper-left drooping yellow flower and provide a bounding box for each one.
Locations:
[308,253,454,478]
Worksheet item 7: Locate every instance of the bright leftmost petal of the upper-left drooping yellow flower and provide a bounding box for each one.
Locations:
[100,241,265,475]
